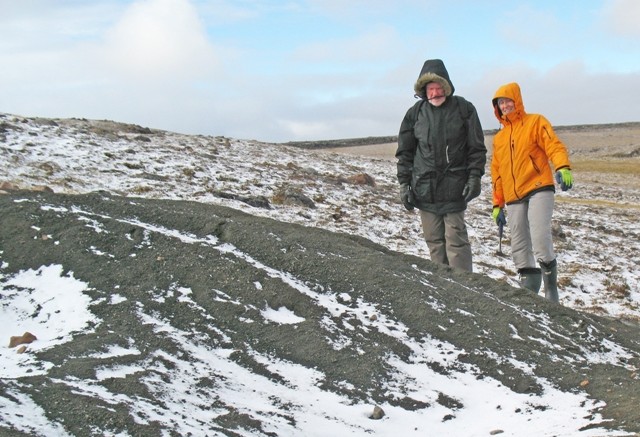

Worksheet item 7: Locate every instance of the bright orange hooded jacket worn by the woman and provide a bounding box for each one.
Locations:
[491,83,571,208]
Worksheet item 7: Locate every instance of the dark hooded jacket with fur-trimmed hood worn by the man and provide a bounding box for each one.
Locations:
[396,59,487,215]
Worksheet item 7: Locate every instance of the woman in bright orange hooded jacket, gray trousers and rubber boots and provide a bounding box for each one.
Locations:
[491,83,573,302]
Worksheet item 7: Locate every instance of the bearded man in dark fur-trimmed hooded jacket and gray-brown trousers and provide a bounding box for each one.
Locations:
[396,59,487,271]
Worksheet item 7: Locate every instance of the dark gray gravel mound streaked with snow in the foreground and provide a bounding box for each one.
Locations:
[0,191,640,435]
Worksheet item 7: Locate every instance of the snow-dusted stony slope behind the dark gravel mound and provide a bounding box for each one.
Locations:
[5,116,640,320]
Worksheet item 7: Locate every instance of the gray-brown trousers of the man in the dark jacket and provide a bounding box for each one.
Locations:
[420,211,473,272]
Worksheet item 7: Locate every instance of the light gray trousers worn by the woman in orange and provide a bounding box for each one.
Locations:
[507,191,556,269]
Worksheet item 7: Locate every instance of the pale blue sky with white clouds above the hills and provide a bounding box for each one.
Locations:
[0,0,640,142]
